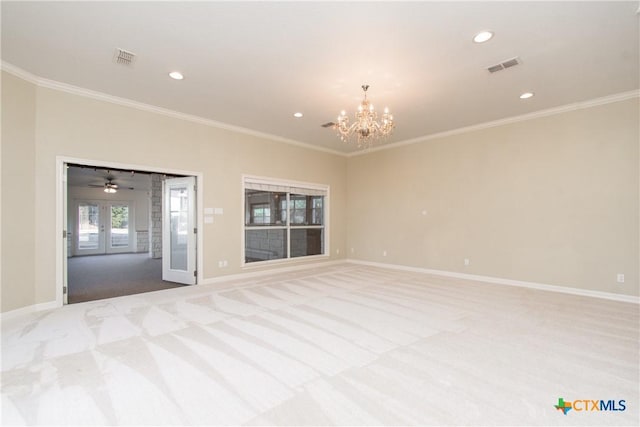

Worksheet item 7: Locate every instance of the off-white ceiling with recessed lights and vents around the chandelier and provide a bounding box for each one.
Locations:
[2,1,640,153]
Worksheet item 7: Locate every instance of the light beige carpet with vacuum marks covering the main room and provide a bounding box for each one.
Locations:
[2,264,640,426]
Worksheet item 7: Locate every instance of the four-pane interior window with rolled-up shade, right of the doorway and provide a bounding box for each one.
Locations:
[244,177,328,263]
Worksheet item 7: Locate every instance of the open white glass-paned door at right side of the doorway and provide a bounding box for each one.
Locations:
[162,177,196,285]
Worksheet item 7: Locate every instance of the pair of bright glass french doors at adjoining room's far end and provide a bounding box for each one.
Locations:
[74,200,134,255]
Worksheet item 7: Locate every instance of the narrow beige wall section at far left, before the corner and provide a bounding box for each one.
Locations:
[0,73,36,312]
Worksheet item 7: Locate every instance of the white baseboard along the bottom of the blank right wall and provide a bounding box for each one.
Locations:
[346,259,640,304]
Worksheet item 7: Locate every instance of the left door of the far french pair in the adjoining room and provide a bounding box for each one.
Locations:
[75,201,105,255]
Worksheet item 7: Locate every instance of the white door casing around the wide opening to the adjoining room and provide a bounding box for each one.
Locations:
[55,156,204,307]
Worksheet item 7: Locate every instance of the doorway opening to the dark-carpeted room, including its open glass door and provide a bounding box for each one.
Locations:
[59,159,198,304]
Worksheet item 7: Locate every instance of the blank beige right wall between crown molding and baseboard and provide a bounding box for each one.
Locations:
[348,99,640,295]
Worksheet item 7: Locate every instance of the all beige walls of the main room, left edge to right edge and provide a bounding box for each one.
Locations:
[1,68,640,312]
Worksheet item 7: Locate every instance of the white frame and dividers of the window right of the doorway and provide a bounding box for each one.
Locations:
[240,175,331,268]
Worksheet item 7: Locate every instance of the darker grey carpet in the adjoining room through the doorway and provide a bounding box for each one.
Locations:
[67,253,182,304]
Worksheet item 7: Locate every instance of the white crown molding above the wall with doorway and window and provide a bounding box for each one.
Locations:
[0,61,346,157]
